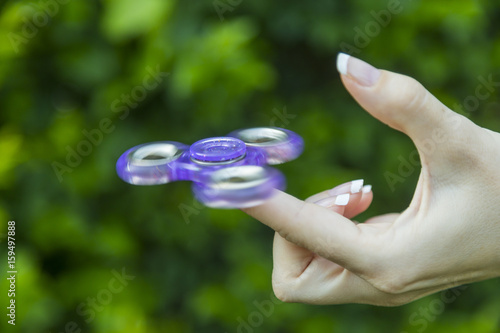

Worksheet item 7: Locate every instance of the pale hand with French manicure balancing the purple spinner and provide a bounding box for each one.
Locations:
[244,54,500,306]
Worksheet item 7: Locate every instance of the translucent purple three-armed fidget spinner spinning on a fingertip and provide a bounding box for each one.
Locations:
[116,127,304,208]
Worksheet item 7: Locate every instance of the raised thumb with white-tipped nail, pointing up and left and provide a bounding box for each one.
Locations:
[337,53,473,155]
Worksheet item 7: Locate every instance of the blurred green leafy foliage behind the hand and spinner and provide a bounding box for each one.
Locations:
[0,0,500,333]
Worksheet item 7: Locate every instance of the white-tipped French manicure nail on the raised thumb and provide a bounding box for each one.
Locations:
[337,53,381,87]
